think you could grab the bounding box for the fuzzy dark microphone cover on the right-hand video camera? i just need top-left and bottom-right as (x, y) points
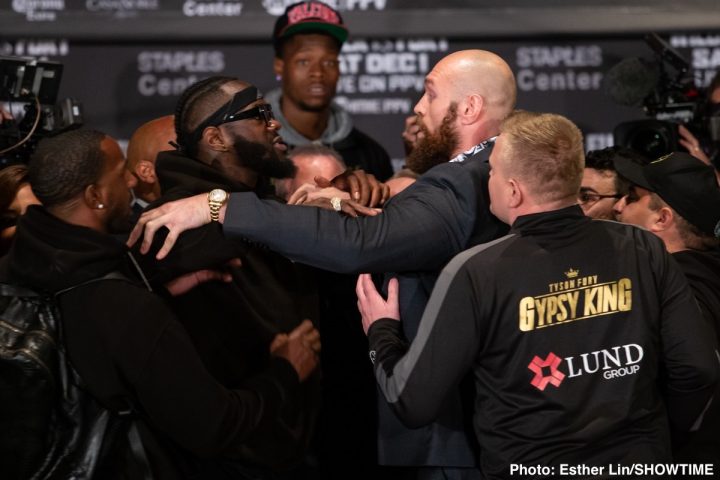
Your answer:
(602, 57), (660, 107)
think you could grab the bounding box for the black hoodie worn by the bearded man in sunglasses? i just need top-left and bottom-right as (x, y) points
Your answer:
(136, 152), (320, 470)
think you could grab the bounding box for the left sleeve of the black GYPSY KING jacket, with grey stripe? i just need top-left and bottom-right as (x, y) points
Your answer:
(368, 257), (482, 428)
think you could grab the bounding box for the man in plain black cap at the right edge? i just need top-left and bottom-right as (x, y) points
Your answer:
(614, 152), (720, 464)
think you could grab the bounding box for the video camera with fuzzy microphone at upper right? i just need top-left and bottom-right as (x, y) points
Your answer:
(603, 33), (720, 159)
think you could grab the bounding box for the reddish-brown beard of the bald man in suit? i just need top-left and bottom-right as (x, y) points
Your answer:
(405, 103), (460, 175)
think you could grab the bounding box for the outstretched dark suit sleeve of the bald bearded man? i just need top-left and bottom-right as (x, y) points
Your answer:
(223, 164), (479, 273)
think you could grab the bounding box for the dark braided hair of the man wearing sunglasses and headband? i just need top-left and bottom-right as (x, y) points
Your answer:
(175, 75), (240, 156)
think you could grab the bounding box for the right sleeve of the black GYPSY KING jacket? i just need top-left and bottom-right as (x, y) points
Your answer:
(656, 240), (720, 430)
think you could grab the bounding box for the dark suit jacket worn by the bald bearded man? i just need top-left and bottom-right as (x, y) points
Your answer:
(217, 150), (507, 467)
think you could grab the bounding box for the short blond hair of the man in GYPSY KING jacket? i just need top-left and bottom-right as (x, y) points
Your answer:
(500, 110), (585, 202)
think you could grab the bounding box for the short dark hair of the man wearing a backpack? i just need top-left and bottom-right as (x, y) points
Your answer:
(28, 130), (106, 207)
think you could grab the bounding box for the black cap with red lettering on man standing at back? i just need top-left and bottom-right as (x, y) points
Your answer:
(273, 1), (348, 50)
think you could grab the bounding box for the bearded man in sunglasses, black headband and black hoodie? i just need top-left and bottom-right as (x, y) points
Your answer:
(131, 76), (320, 478)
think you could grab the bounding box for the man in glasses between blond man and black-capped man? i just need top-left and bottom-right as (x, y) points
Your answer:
(578, 146), (647, 220)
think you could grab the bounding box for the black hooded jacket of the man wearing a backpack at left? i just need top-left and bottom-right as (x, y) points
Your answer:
(0, 206), (298, 479)
